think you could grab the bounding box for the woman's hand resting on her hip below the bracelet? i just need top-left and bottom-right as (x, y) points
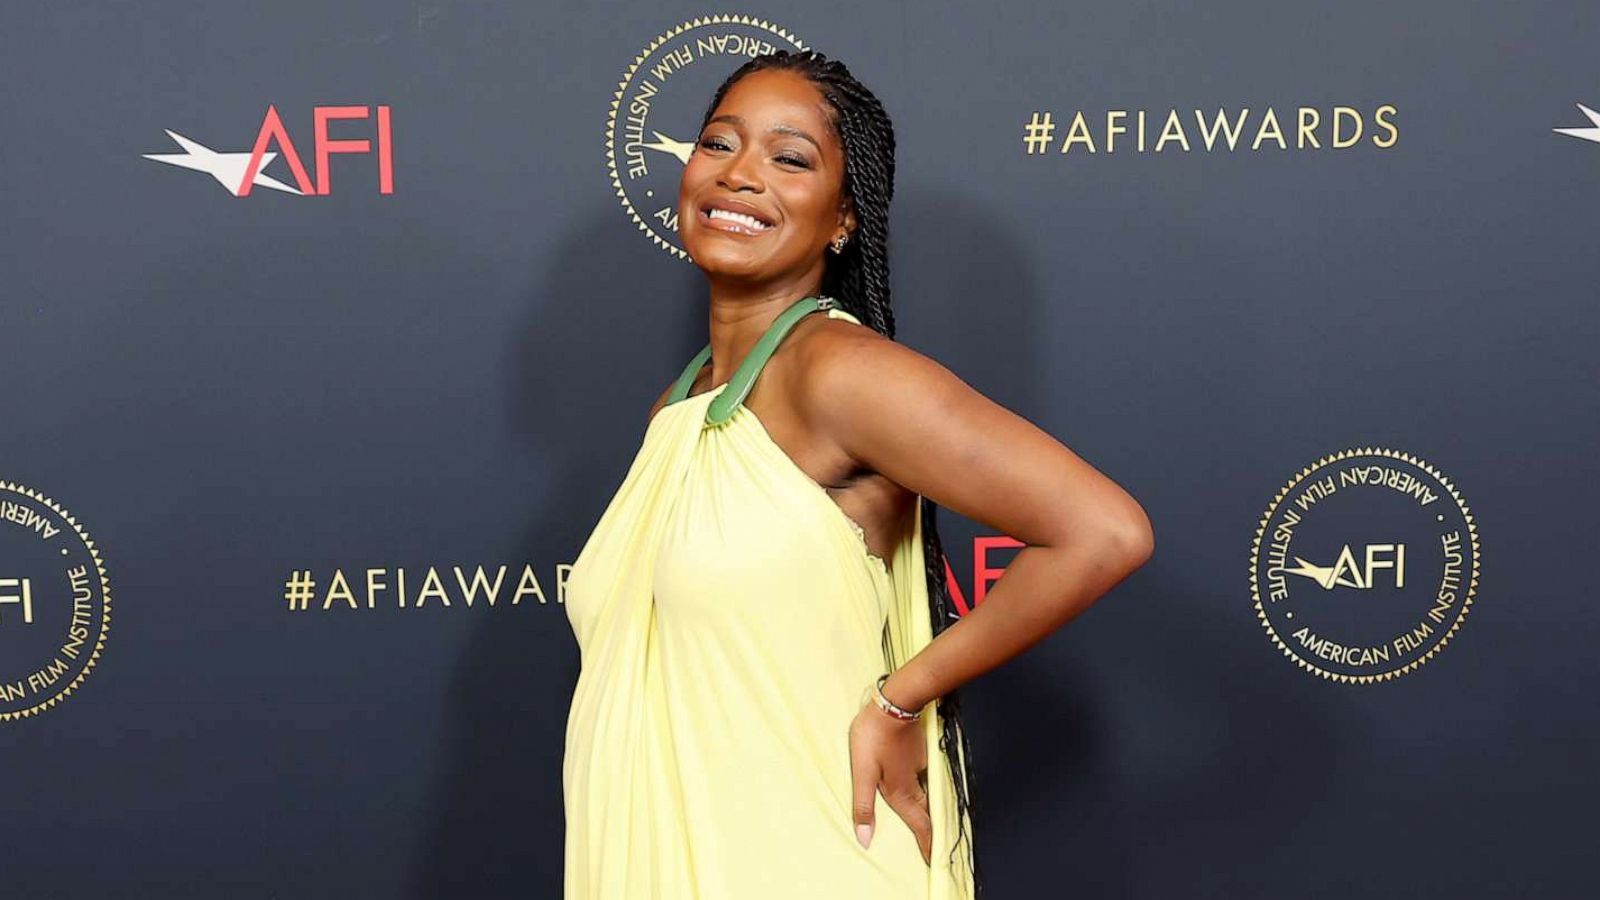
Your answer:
(850, 685), (933, 863)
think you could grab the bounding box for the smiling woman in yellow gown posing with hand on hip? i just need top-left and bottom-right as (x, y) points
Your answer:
(563, 51), (1154, 900)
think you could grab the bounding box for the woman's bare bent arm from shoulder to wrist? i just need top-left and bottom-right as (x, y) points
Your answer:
(798, 328), (1155, 709)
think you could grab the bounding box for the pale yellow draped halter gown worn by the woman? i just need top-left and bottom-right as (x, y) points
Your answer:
(562, 298), (973, 900)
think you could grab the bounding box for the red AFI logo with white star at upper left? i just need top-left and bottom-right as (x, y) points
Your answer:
(144, 106), (395, 197)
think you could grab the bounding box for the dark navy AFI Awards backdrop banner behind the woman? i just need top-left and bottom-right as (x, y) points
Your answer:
(0, 0), (1600, 900)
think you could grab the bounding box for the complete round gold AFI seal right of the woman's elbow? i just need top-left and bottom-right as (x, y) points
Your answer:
(1250, 447), (1478, 684)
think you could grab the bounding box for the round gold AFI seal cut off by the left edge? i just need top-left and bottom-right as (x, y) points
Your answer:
(0, 480), (110, 722)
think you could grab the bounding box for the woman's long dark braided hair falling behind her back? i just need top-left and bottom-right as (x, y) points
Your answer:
(701, 50), (981, 890)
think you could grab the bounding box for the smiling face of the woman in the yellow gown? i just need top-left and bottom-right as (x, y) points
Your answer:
(678, 69), (856, 282)
